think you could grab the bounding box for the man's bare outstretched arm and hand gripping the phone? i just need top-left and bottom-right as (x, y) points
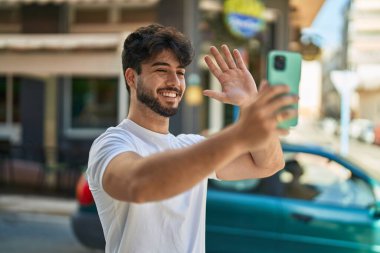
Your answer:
(102, 86), (295, 203)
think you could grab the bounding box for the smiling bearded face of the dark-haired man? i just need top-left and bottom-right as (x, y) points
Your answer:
(136, 50), (186, 117)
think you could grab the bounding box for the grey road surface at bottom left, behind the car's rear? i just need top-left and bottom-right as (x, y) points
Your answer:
(0, 212), (102, 253)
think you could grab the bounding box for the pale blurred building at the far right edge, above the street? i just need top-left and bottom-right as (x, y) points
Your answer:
(347, 0), (380, 124)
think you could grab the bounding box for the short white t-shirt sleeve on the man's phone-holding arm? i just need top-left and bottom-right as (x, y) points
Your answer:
(87, 129), (137, 189)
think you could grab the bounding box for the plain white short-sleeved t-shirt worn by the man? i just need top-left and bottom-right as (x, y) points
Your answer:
(87, 119), (215, 253)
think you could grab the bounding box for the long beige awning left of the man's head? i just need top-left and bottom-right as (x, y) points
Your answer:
(0, 34), (125, 76)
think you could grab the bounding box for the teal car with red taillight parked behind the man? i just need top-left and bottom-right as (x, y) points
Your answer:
(72, 144), (380, 253)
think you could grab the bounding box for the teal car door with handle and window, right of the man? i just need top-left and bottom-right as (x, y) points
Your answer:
(280, 153), (380, 253)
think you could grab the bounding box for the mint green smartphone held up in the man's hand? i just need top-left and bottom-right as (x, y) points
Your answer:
(267, 50), (302, 129)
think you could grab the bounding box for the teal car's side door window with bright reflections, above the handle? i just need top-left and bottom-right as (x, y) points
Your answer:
(280, 153), (375, 208)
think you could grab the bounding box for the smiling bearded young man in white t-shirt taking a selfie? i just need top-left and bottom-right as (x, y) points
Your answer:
(87, 25), (298, 253)
